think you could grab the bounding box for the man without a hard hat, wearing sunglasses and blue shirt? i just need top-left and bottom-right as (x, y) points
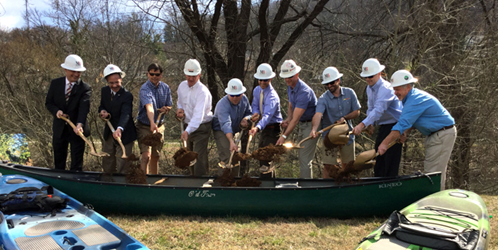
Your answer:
(136, 63), (173, 174)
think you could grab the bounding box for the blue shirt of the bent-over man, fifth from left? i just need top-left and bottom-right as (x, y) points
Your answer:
(213, 95), (252, 134)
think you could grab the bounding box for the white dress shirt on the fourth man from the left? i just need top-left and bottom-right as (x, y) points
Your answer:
(177, 81), (213, 134)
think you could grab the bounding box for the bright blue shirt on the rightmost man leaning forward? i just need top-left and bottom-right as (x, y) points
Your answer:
(392, 88), (455, 136)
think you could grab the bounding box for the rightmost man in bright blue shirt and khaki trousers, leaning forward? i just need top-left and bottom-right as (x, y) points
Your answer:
(378, 70), (457, 190)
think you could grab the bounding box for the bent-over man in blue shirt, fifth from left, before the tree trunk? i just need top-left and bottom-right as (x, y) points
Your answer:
(213, 78), (252, 176)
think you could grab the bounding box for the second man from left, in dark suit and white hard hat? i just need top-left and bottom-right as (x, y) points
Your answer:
(99, 64), (137, 174)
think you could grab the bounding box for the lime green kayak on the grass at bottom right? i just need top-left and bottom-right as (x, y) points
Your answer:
(356, 189), (490, 250)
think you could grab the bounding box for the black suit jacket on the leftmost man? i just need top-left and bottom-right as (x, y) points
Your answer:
(45, 77), (92, 138)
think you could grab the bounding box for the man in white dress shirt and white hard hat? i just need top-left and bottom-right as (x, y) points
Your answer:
(176, 59), (213, 176)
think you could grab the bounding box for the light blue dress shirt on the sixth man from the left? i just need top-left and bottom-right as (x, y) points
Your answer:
(252, 83), (283, 131)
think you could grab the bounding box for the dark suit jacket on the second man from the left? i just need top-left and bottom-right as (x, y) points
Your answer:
(99, 86), (137, 145)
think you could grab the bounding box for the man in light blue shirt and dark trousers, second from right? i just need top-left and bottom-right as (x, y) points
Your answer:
(353, 58), (403, 177)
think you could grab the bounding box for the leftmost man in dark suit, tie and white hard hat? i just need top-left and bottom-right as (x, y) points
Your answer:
(45, 55), (92, 171)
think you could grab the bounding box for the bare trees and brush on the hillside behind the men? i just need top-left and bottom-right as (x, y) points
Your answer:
(0, 0), (498, 193)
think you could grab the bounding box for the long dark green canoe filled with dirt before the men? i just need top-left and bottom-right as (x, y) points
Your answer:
(0, 163), (441, 218)
